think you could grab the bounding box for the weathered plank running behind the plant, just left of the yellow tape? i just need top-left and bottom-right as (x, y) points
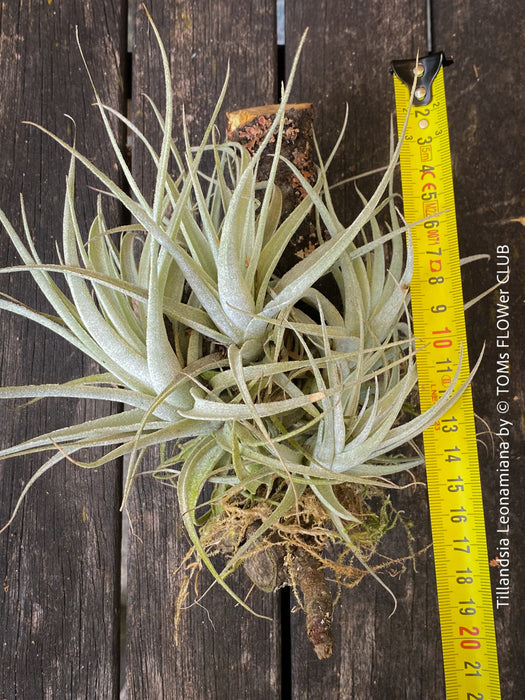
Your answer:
(286, 0), (450, 700)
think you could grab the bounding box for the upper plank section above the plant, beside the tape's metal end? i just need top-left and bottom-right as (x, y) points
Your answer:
(285, 0), (426, 223)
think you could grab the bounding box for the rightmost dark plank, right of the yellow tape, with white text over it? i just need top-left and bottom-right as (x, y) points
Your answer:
(434, 0), (525, 698)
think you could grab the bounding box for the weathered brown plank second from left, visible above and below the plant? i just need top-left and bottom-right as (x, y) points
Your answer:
(127, 0), (280, 700)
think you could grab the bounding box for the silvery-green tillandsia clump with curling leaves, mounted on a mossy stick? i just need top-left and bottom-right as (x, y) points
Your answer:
(0, 19), (476, 657)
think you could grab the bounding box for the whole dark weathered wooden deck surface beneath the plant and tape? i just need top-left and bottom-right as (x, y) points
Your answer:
(0, 0), (525, 700)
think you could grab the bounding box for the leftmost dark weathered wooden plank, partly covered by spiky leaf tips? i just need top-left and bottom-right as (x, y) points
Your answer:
(0, 0), (123, 699)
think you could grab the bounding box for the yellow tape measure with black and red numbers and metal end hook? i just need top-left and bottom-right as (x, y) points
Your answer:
(392, 53), (501, 700)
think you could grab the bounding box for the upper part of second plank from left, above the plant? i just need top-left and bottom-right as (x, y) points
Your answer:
(133, 0), (277, 201)
